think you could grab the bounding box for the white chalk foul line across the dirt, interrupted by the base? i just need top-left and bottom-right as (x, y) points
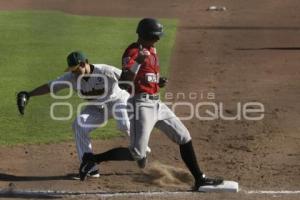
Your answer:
(0, 189), (300, 197)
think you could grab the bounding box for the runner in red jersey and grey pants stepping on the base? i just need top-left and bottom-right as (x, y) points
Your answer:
(80, 18), (223, 190)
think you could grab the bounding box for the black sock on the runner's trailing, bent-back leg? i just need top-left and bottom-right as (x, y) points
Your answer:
(93, 147), (134, 163)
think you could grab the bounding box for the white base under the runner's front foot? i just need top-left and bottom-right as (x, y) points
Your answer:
(198, 181), (239, 192)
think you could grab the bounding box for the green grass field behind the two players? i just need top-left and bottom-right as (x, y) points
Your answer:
(0, 11), (177, 145)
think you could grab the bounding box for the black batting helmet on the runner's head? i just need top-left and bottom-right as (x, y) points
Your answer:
(136, 18), (163, 40)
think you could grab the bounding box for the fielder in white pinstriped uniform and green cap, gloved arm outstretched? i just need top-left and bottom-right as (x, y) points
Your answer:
(17, 51), (130, 177)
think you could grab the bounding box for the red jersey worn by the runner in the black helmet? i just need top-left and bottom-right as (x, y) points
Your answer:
(122, 43), (160, 94)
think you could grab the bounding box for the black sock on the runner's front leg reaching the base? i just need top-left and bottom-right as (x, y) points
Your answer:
(180, 141), (203, 181)
